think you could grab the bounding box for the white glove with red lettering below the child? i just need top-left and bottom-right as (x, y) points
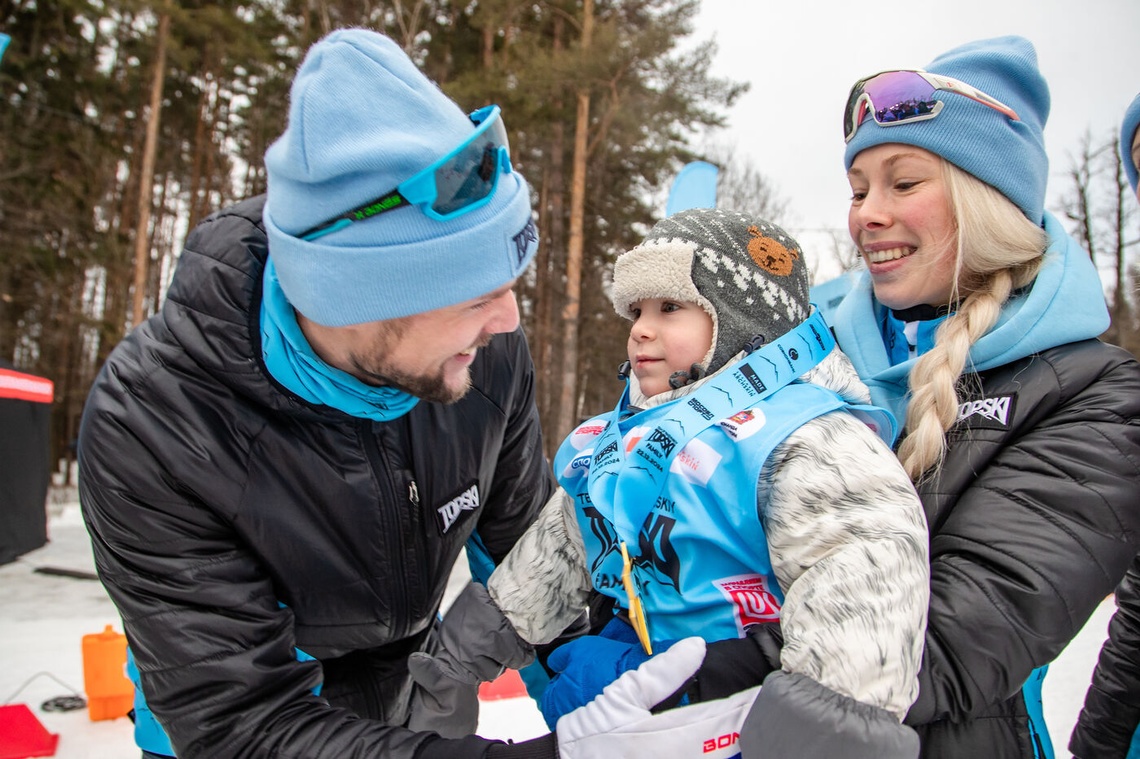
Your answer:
(556, 638), (760, 759)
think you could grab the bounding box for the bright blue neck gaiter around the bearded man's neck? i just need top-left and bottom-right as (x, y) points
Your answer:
(261, 258), (420, 422)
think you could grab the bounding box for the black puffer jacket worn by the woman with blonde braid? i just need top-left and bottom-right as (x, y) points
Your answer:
(906, 340), (1140, 759)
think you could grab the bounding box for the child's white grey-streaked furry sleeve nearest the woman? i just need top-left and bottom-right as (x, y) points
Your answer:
(759, 411), (930, 720)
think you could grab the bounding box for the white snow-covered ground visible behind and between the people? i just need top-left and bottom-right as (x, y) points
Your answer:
(0, 499), (1115, 759)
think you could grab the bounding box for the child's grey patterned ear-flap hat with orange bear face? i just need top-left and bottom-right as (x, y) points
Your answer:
(613, 209), (811, 373)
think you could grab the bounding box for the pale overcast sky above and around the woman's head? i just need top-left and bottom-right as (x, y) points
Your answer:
(694, 0), (1140, 254)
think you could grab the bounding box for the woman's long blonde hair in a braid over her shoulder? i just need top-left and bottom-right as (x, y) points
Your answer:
(898, 161), (1048, 482)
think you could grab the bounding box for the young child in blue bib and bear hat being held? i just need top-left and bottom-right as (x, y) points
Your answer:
(421, 210), (929, 757)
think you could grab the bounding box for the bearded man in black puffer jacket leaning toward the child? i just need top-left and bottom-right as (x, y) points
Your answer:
(80, 30), (725, 759)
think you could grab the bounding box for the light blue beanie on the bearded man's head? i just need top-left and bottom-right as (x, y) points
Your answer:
(263, 28), (538, 327)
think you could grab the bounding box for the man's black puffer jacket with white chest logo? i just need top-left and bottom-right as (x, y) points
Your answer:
(80, 198), (552, 759)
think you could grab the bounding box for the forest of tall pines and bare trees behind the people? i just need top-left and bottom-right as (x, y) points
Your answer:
(0, 0), (1140, 476)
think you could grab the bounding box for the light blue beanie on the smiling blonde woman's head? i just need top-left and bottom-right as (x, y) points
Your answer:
(844, 36), (1050, 225)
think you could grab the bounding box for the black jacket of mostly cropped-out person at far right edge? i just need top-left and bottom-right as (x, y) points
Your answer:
(1069, 555), (1140, 759)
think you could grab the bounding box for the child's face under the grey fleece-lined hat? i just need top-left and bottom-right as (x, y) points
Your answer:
(626, 297), (713, 397)
